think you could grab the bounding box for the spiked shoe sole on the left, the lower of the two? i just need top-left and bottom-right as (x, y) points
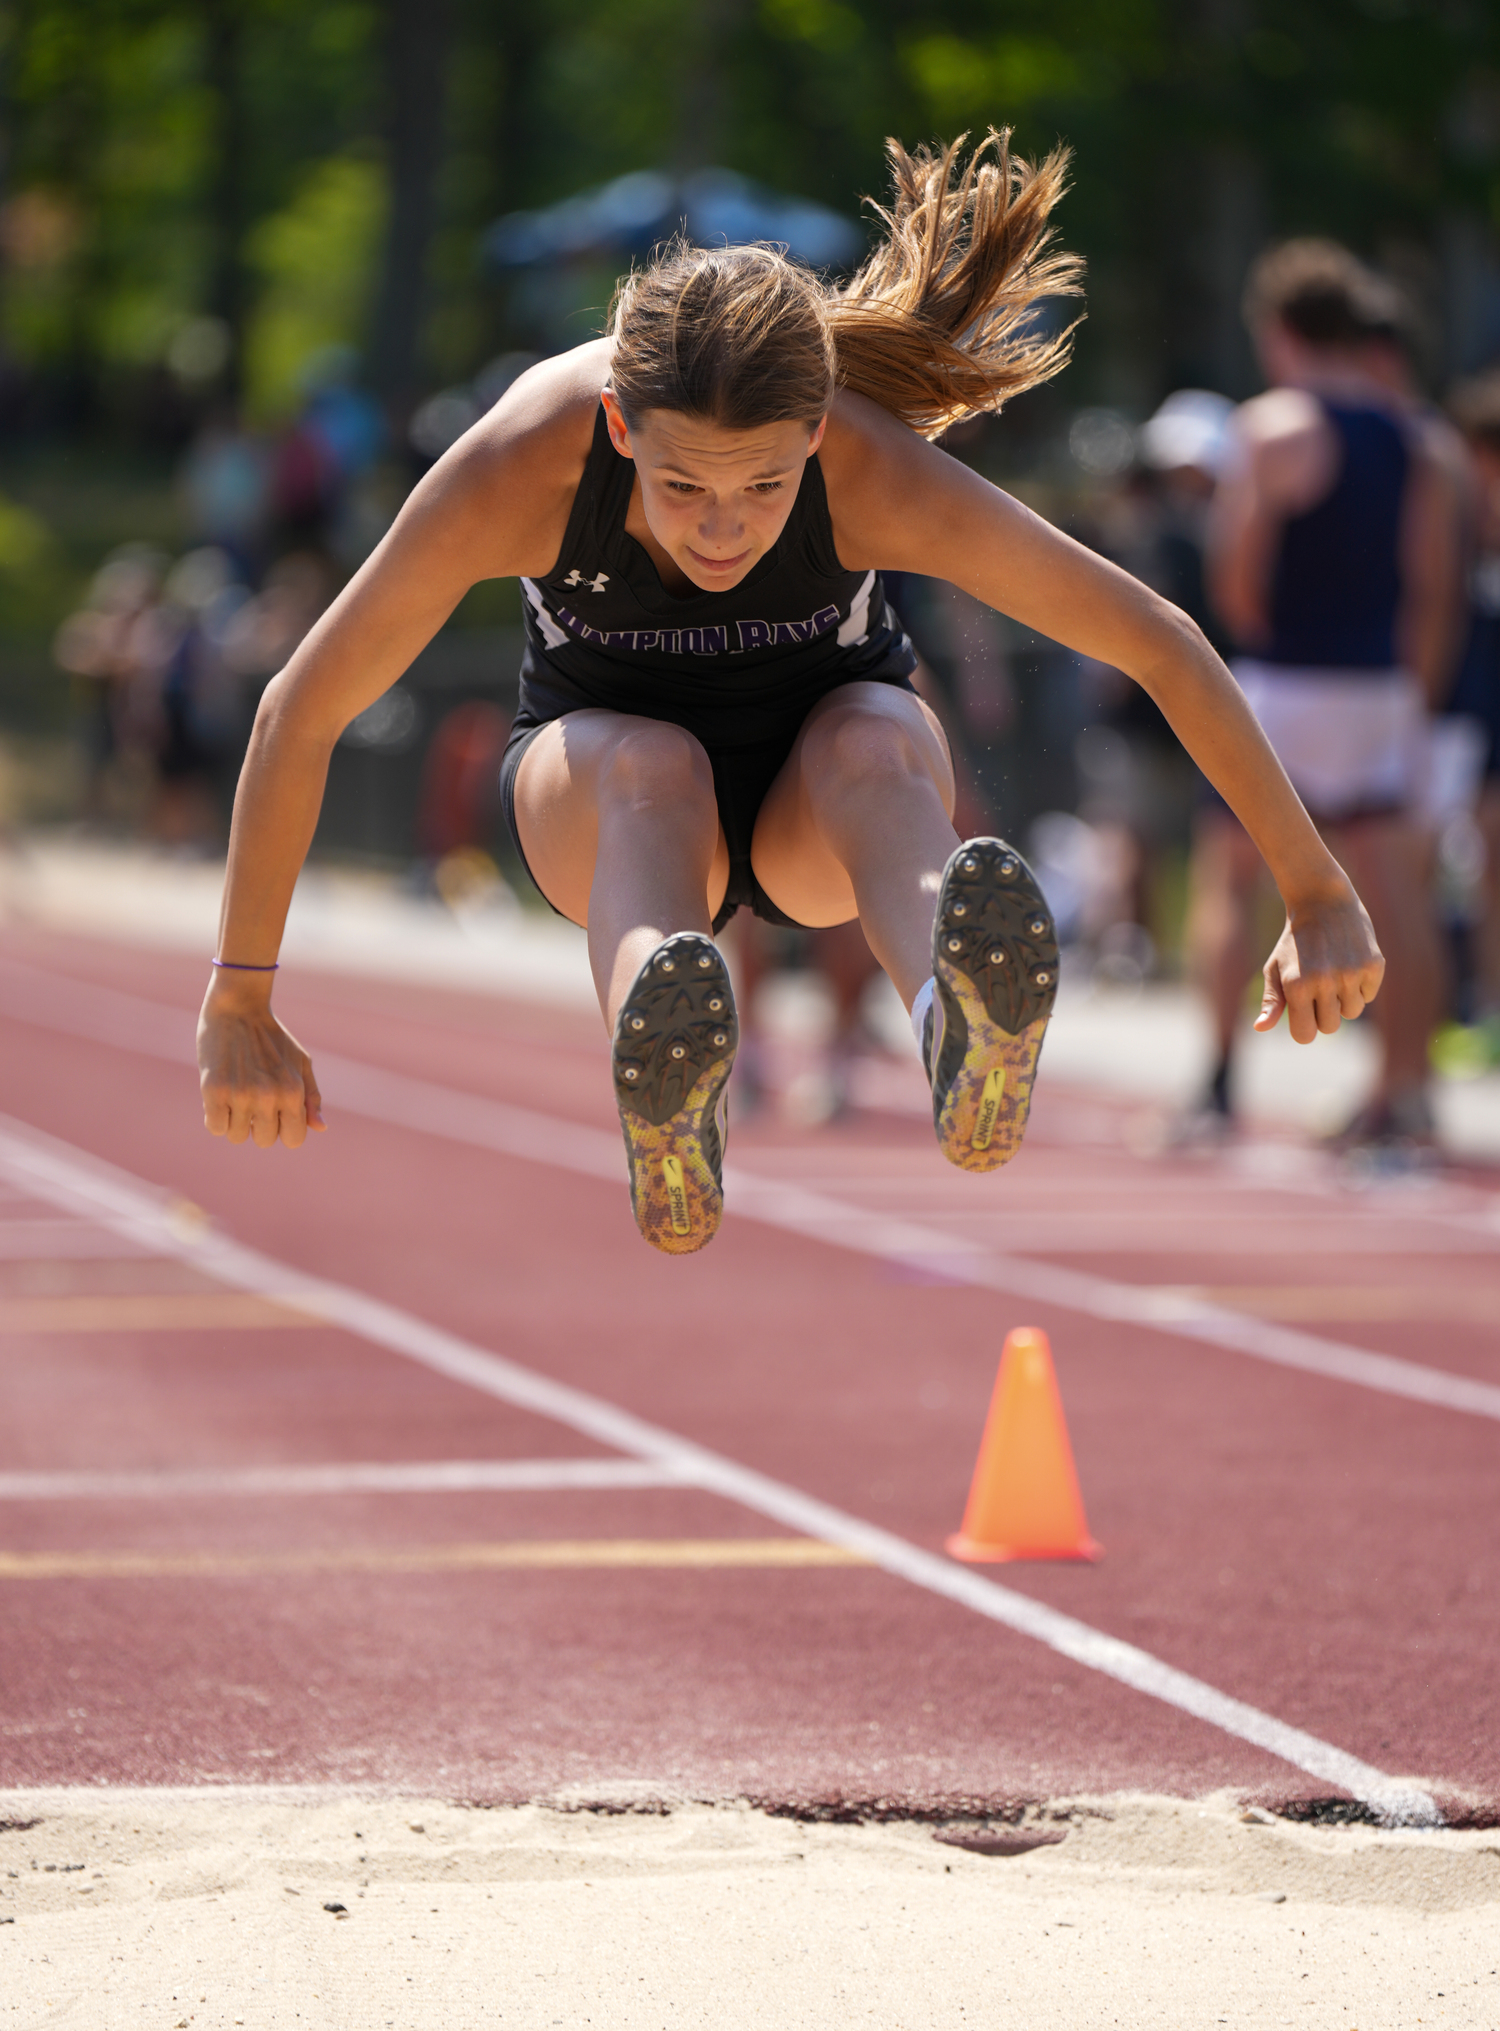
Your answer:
(613, 930), (739, 1255)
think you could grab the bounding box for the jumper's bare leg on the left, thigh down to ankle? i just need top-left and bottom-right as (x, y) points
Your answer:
(516, 709), (729, 1028)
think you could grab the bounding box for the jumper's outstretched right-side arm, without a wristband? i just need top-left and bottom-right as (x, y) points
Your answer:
(822, 394), (1384, 1044)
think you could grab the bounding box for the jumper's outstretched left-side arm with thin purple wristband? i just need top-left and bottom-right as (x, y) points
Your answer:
(199, 345), (605, 1148)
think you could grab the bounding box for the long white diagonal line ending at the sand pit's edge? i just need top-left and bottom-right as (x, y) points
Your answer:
(0, 1117), (1441, 1826)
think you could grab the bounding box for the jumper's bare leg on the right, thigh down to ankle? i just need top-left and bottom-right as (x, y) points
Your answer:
(751, 682), (958, 1007)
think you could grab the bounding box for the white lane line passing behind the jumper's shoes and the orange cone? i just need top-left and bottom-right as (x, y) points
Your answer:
(0, 961), (1500, 1420)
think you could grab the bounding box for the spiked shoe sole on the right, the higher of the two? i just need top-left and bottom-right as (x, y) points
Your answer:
(922, 839), (1058, 1170)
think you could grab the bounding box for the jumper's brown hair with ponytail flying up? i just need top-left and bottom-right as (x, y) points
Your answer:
(609, 128), (1082, 437)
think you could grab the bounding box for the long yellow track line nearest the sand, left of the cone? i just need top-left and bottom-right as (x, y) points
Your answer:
(0, 1537), (871, 1580)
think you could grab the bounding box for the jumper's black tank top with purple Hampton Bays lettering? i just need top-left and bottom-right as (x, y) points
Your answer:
(518, 402), (915, 749)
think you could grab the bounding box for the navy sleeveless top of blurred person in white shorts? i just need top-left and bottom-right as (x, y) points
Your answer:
(1263, 402), (1411, 670)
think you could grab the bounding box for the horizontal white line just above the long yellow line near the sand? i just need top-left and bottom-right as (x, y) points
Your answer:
(0, 1460), (684, 1503)
